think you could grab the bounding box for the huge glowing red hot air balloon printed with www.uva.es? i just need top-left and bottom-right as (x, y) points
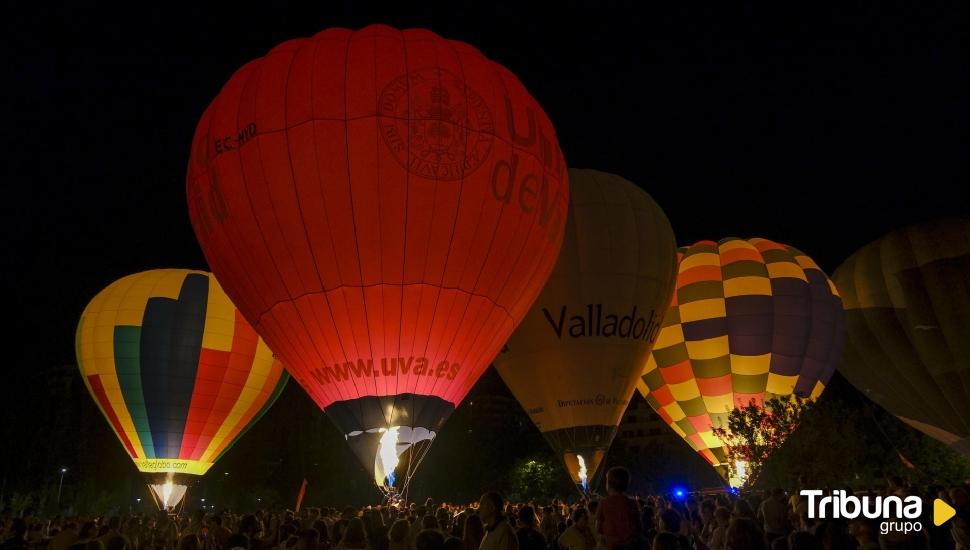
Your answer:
(186, 26), (568, 496)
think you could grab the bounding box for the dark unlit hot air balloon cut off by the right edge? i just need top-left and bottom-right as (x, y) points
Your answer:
(833, 219), (970, 456)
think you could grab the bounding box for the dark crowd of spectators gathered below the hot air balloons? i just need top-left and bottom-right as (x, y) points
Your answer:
(0, 468), (970, 550)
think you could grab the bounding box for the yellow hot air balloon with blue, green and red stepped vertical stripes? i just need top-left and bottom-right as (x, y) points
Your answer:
(76, 269), (289, 510)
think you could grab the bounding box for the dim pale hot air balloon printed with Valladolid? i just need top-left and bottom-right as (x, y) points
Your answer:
(495, 169), (677, 491)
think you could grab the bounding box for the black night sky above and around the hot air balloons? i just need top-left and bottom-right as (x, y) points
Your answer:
(0, 1), (970, 504)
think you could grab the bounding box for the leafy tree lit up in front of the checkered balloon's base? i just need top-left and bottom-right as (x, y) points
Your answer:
(713, 396), (811, 487)
